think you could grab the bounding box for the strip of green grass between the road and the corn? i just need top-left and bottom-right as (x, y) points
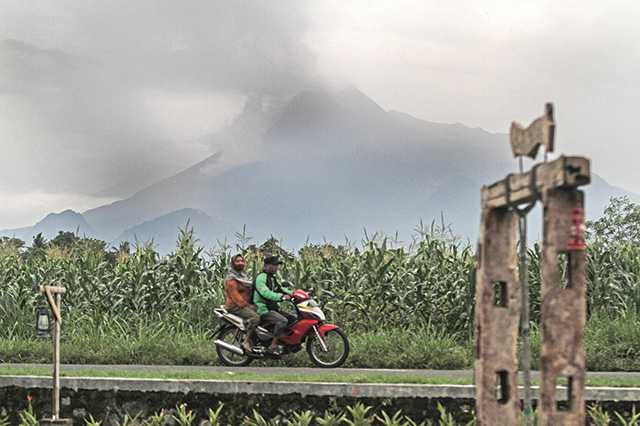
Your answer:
(6, 314), (640, 371)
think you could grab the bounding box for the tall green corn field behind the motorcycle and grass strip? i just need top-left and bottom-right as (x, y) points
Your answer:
(0, 197), (640, 339)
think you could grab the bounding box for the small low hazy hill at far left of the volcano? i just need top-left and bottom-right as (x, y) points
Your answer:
(0, 210), (95, 243)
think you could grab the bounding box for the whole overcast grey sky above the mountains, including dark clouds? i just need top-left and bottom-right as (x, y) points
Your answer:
(0, 0), (640, 228)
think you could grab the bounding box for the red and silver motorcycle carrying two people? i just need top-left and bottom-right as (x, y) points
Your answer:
(214, 290), (349, 368)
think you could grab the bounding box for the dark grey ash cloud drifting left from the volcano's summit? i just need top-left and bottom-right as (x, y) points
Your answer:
(0, 0), (314, 201)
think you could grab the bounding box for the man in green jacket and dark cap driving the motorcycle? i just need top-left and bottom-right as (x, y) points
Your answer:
(253, 256), (296, 354)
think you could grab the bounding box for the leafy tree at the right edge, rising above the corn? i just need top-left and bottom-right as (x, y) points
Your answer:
(587, 196), (640, 243)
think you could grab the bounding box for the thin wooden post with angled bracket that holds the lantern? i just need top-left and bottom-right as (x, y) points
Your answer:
(39, 285), (73, 426)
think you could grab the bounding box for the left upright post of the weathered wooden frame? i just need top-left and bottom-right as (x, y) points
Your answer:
(474, 208), (521, 425)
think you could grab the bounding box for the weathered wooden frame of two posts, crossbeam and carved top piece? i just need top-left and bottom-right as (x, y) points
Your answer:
(474, 104), (591, 425)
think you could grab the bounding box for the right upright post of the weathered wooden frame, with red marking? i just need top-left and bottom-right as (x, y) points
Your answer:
(539, 189), (586, 426)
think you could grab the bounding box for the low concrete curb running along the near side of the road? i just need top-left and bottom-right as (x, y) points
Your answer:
(0, 376), (640, 402)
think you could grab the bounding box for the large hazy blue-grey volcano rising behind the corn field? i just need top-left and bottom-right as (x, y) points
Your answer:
(7, 88), (635, 248)
